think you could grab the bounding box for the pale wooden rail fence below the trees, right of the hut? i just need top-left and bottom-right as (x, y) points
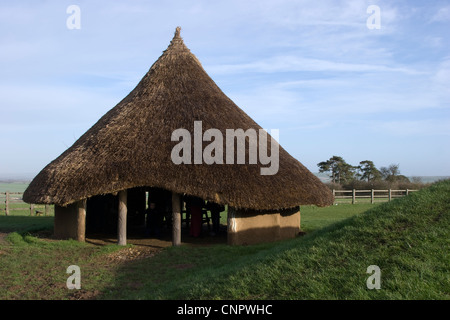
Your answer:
(333, 189), (417, 204)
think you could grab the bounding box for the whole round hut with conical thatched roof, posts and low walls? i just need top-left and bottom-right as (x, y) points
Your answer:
(23, 28), (333, 244)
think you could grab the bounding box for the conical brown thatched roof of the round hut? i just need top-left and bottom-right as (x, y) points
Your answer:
(23, 28), (333, 210)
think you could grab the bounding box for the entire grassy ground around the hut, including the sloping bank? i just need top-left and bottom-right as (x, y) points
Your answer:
(0, 181), (450, 300)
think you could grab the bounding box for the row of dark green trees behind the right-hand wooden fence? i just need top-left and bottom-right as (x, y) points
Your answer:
(317, 156), (426, 189)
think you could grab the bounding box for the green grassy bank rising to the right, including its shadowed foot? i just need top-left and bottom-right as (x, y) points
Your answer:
(103, 181), (450, 299)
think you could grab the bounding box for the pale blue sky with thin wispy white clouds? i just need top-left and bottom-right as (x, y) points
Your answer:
(0, 0), (450, 178)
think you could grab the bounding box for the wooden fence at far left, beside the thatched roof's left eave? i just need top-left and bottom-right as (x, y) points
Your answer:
(0, 191), (52, 216)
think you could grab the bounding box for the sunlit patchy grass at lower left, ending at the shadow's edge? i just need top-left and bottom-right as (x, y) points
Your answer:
(0, 232), (123, 300)
